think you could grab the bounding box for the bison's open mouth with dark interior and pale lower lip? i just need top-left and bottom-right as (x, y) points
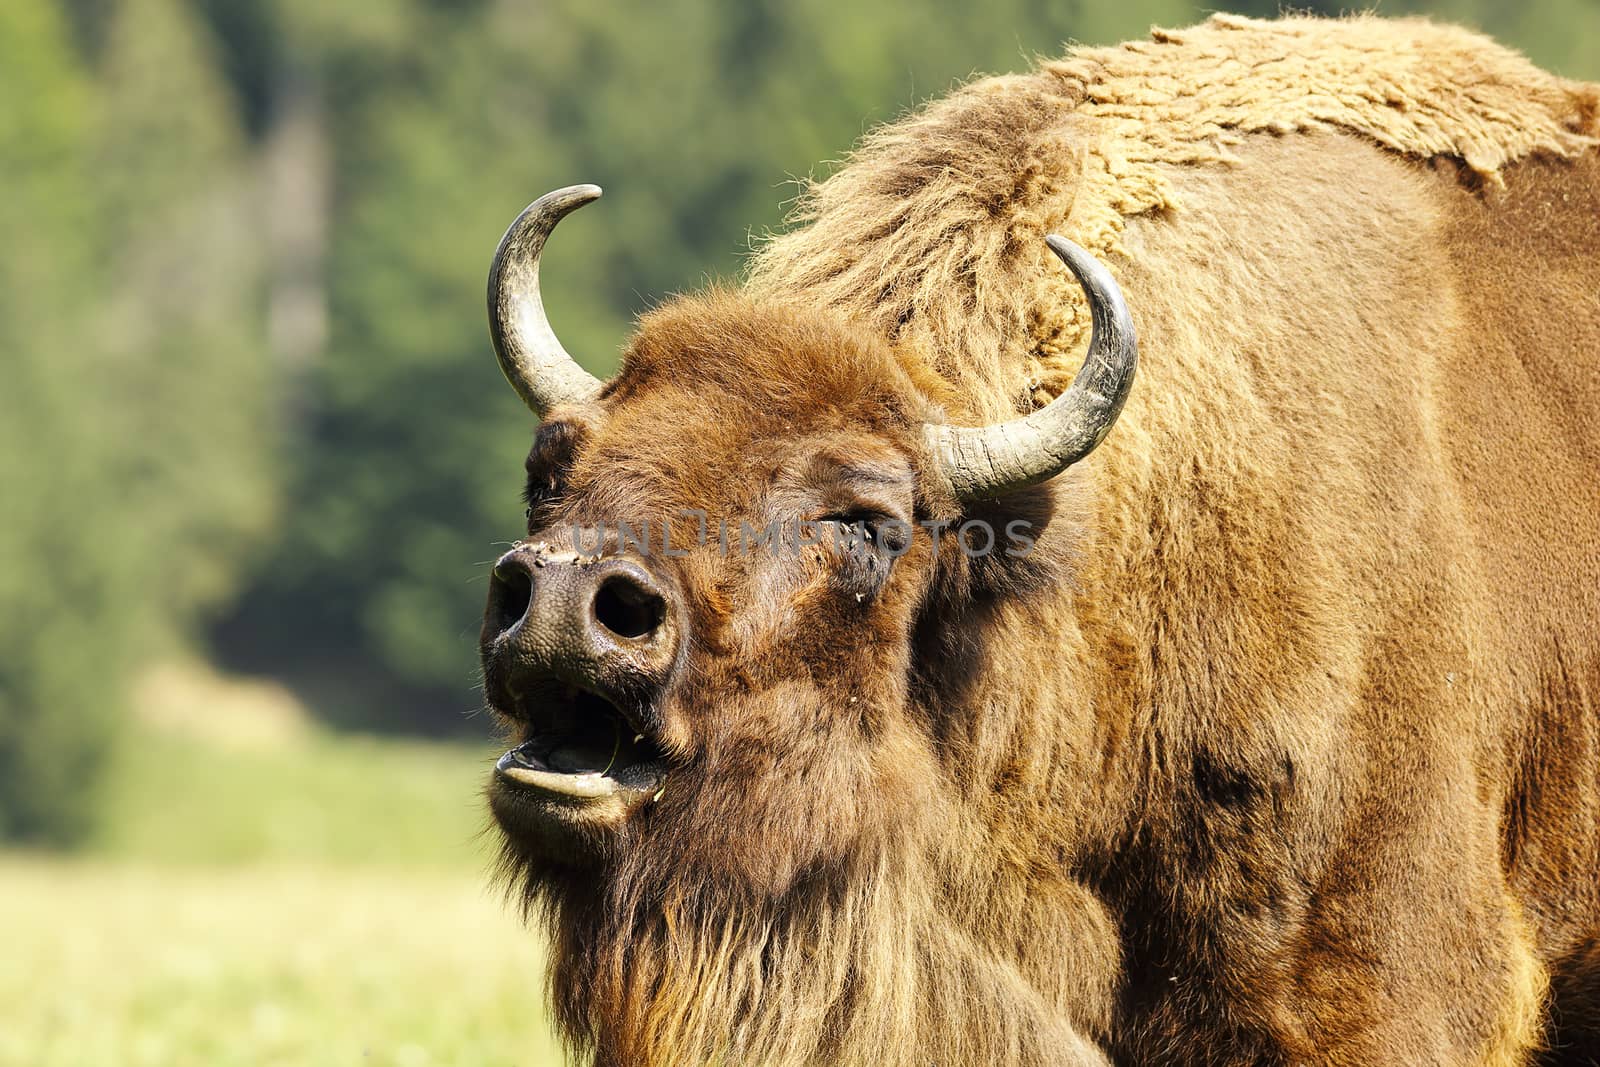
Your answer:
(494, 685), (667, 800)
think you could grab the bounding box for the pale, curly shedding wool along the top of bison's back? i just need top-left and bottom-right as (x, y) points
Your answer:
(1043, 14), (1600, 251)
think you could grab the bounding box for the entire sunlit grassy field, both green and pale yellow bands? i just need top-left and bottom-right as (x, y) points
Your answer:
(0, 668), (562, 1067)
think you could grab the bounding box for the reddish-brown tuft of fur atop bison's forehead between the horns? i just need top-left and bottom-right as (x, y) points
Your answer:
(606, 290), (955, 432)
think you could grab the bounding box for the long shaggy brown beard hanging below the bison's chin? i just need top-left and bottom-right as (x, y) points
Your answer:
(510, 835), (1107, 1067)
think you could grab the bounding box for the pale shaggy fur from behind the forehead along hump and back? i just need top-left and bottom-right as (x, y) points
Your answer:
(749, 14), (1600, 418)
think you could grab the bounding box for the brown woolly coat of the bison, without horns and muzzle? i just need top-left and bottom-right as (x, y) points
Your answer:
(492, 18), (1600, 1067)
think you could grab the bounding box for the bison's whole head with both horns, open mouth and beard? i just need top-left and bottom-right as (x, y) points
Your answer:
(482, 187), (1136, 1062)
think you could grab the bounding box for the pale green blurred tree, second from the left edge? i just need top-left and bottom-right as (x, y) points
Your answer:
(93, 0), (277, 625)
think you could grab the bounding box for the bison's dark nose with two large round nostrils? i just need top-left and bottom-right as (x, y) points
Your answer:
(483, 545), (674, 688)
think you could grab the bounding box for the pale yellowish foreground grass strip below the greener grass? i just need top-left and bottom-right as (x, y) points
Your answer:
(0, 857), (562, 1067)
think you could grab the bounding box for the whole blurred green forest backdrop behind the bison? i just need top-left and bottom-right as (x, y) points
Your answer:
(0, 0), (1600, 841)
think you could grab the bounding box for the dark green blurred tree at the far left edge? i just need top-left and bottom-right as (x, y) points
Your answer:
(0, 0), (116, 840)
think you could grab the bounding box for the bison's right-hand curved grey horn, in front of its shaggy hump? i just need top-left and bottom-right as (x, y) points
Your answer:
(928, 234), (1139, 501)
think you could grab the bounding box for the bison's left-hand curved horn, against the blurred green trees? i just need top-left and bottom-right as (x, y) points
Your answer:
(490, 186), (602, 416)
